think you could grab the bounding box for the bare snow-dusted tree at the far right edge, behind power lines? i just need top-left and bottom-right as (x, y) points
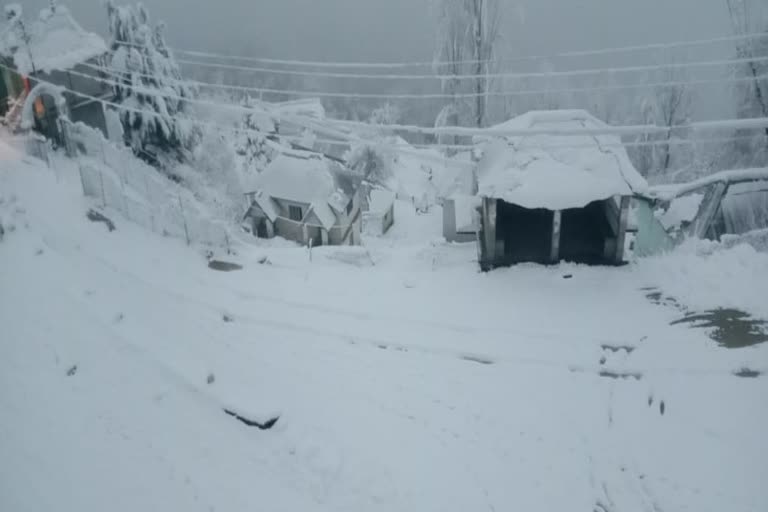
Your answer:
(725, 0), (768, 166)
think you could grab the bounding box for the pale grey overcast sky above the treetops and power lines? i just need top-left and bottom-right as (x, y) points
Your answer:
(25, 0), (752, 117)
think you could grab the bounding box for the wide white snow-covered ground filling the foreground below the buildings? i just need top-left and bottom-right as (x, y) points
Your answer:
(0, 142), (768, 512)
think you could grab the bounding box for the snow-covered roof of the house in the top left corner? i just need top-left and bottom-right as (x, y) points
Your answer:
(0, 5), (107, 75)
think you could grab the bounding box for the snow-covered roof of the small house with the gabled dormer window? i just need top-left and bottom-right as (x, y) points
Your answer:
(247, 151), (354, 229)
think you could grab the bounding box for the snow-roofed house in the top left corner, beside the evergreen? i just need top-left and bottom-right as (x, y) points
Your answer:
(0, 3), (112, 140)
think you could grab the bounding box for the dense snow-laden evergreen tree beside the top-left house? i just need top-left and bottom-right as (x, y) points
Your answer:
(107, 0), (196, 159)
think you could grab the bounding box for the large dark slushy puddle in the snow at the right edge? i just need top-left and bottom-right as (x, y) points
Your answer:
(671, 309), (768, 348)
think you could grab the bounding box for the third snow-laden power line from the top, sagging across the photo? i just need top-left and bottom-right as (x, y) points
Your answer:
(83, 59), (768, 100)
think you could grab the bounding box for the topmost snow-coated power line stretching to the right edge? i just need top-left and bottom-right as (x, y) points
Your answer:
(166, 32), (766, 69)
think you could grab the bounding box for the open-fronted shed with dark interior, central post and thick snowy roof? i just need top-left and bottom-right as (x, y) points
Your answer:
(477, 110), (647, 270)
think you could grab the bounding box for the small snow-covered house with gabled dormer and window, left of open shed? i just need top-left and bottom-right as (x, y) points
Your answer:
(245, 151), (362, 246)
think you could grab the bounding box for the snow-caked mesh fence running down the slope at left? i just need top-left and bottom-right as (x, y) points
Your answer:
(62, 120), (231, 248)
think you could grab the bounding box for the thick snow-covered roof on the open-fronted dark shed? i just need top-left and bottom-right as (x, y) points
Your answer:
(476, 110), (648, 210)
